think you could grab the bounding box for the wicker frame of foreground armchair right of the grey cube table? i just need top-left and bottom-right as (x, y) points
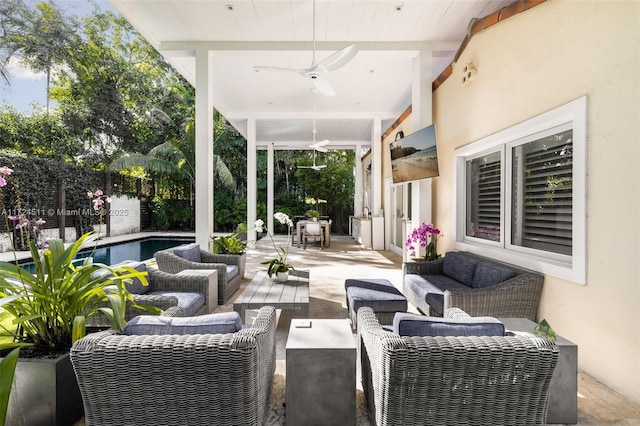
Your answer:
(358, 307), (558, 426)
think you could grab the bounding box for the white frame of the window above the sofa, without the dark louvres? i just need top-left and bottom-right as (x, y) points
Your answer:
(454, 96), (587, 284)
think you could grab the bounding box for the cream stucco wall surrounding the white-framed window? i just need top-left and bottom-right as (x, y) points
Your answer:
(433, 0), (640, 402)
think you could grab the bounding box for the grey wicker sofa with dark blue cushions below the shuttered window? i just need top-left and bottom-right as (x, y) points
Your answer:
(403, 252), (544, 321)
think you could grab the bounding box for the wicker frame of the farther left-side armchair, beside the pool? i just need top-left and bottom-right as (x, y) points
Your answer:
(154, 249), (247, 305)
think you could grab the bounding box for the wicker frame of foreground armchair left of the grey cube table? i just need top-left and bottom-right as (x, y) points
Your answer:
(71, 307), (276, 426)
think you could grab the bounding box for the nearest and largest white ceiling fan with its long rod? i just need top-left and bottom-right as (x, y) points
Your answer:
(254, 0), (358, 96)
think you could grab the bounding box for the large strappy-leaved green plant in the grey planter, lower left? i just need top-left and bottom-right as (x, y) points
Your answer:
(0, 233), (147, 353)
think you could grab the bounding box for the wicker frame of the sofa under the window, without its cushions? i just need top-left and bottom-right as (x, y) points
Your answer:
(403, 252), (544, 321)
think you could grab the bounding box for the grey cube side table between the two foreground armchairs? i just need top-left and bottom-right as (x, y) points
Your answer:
(286, 319), (356, 426)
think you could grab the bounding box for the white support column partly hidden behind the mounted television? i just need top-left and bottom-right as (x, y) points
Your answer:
(411, 50), (433, 227)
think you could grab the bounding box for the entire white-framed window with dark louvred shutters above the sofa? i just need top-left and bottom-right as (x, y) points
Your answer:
(455, 98), (586, 283)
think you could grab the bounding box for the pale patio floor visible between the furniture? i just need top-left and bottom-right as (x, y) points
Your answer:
(217, 235), (640, 425)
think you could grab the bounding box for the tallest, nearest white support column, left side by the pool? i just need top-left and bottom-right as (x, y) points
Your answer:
(195, 49), (213, 249)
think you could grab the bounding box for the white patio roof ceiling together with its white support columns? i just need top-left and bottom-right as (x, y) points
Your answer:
(111, 0), (502, 244)
